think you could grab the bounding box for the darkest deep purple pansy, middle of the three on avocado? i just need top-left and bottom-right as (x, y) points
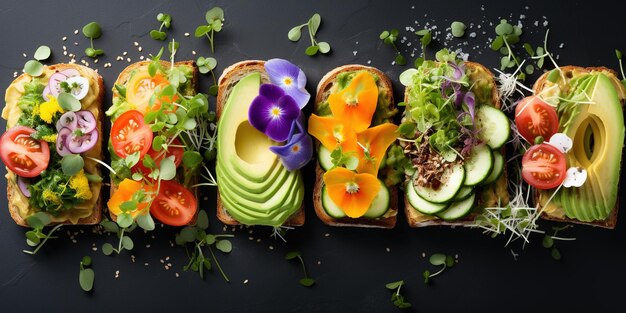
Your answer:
(248, 84), (300, 142)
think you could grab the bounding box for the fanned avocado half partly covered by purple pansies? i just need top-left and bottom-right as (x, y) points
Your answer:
(216, 72), (304, 226)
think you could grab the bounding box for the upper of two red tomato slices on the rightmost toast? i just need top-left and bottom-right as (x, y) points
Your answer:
(515, 96), (559, 144)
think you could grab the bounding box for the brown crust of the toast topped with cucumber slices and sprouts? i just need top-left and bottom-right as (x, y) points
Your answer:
(404, 61), (509, 228)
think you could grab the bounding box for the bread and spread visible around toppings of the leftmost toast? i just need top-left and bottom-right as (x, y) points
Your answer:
(2, 64), (104, 226)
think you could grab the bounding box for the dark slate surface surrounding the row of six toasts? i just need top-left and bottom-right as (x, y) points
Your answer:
(0, 0), (626, 312)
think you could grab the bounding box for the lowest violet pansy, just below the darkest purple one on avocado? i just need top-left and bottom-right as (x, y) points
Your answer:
(270, 118), (313, 171)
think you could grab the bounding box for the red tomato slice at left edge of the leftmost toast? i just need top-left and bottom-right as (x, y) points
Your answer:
(0, 126), (50, 177)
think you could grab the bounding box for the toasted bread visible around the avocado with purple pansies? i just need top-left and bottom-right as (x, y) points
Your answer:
(215, 60), (305, 226)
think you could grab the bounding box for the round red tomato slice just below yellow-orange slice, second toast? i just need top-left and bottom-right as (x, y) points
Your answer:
(111, 110), (152, 158)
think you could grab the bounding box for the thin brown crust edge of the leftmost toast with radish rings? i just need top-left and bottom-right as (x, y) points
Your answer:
(7, 63), (105, 227)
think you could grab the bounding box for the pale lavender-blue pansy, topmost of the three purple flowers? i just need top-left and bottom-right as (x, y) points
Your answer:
(265, 59), (311, 109)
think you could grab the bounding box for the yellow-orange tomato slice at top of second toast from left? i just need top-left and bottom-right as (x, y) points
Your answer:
(126, 70), (178, 114)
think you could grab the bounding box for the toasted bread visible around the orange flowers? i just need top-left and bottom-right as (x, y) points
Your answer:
(313, 64), (398, 228)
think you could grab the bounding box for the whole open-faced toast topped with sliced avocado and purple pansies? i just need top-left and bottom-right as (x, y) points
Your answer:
(215, 59), (312, 227)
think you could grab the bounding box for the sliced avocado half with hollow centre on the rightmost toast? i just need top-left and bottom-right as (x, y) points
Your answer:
(540, 72), (625, 222)
